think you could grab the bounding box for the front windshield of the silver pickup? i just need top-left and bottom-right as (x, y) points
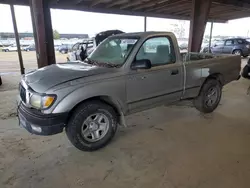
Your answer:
(88, 37), (138, 66)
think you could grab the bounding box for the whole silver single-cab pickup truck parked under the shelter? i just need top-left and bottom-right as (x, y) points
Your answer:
(18, 32), (241, 151)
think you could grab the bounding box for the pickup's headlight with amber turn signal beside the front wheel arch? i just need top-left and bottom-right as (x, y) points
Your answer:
(30, 94), (56, 109)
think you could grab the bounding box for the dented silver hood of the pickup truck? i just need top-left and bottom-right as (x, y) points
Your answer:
(24, 62), (114, 93)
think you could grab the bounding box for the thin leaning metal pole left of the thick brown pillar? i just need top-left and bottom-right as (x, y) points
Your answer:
(10, 5), (25, 74)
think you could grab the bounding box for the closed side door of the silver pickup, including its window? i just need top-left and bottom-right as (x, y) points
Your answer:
(126, 37), (183, 112)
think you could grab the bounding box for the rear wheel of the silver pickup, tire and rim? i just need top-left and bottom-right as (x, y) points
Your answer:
(194, 79), (222, 113)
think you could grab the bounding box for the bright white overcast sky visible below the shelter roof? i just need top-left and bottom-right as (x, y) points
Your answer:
(0, 4), (250, 37)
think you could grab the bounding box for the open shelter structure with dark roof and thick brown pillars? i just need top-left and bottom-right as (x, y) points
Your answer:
(0, 0), (250, 70)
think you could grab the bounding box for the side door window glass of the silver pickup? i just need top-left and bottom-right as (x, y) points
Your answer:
(136, 37), (176, 66)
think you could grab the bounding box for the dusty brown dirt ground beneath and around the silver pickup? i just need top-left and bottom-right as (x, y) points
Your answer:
(0, 53), (250, 188)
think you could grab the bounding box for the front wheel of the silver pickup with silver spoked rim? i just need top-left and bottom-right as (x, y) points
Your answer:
(66, 101), (118, 151)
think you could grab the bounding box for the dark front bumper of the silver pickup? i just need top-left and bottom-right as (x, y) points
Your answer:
(18, 103), (68, 135)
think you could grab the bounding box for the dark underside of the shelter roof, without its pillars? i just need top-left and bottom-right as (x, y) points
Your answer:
(0, 0), (250, 22)
